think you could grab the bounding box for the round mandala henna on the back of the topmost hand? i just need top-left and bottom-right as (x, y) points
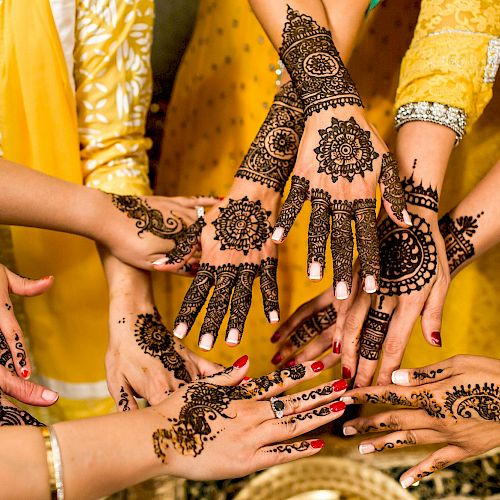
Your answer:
(314, 116), (379, 182)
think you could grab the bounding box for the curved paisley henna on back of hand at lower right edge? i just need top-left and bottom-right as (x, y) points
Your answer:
(444, 382), (500, 422)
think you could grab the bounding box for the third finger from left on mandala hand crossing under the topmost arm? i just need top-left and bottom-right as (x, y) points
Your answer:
(226, 263), (259, 346)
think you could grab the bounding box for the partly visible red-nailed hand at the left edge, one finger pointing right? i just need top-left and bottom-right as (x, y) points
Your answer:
(0, 264), (54, 379)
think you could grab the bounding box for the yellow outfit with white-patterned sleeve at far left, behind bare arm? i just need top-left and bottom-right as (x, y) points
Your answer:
(0, 0), (154, 420)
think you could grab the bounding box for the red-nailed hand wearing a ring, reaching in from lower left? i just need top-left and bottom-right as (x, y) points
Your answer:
(148, 356), (346, 481)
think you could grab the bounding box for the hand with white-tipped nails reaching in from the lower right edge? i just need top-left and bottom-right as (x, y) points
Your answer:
(344, 356), (500, 487)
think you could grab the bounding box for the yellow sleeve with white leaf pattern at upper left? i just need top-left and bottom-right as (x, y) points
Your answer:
(75, 0), (154, 195)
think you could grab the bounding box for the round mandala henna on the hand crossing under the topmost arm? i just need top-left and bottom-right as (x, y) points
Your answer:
(212, 196), (271, 255)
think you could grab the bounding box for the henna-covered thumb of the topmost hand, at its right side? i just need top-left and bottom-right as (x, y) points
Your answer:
(379, 152), (412, 227)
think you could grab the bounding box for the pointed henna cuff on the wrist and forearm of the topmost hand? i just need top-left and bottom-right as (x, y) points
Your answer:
(279, 6), (362, 117)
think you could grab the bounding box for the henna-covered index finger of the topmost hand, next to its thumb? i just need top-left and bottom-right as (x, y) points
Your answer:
(354, 199), (380, 293)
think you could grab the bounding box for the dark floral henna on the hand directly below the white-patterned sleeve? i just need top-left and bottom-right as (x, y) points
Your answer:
(134, 307), (191, 382)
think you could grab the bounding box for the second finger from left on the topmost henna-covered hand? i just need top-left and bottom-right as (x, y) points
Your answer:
(307, 189), (331, 280)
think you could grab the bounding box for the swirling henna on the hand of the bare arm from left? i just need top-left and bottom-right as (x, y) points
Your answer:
(111, 194), (186, 239)
